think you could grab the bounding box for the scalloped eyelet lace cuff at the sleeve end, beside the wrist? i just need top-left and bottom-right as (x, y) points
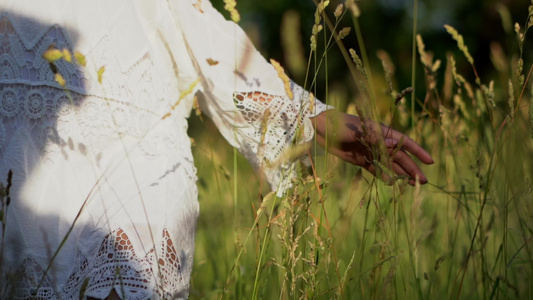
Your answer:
(233, 82), (330, 194)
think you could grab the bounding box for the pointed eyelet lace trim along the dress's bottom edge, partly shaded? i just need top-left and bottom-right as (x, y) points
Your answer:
(2, 229), (190, 299)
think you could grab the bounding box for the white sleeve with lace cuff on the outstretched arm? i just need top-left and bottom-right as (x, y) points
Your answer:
(171, 0), (328, 193)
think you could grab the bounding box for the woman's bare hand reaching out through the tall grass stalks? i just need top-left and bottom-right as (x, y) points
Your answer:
(311, 110), (433, 185)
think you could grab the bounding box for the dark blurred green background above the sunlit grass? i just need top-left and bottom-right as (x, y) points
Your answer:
(212, 0), (533, 101)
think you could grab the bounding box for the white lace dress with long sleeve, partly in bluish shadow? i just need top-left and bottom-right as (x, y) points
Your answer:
(0, 0), (326, 299)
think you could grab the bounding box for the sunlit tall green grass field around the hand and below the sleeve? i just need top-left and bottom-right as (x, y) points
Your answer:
(190, 0), (533, 299)
